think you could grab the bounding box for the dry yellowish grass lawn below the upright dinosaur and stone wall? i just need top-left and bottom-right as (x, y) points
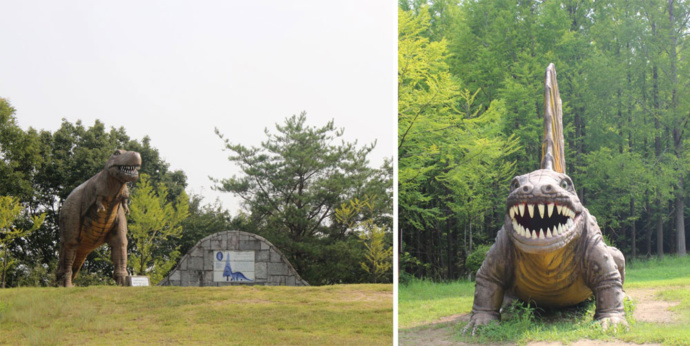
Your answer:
(0, 284), (393, 345)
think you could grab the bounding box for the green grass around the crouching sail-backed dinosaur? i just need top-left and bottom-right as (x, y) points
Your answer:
(398, 256), (690, 345)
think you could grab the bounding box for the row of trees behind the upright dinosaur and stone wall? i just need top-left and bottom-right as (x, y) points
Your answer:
(0, 102), (393, 287)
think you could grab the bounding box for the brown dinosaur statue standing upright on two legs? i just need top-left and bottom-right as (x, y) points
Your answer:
(56, 149), (141, 287)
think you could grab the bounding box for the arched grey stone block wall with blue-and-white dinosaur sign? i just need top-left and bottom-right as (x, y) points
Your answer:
(158, 231), (309, 286)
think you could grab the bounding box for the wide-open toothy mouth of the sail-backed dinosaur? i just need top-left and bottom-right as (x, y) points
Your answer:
(508, 203), (579, 240)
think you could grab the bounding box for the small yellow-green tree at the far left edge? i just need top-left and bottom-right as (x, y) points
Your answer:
(0, 196), (45, 288)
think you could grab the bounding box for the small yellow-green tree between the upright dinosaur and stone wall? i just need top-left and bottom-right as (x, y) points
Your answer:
(128, 173), (189, 284)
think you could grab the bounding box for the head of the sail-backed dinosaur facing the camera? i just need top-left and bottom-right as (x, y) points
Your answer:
(505, 169), (585, 253)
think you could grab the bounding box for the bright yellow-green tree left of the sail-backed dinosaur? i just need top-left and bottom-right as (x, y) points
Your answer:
(398, 8), (517, 278)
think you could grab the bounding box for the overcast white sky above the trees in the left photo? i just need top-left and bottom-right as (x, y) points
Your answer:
(0, 0), (397, 215)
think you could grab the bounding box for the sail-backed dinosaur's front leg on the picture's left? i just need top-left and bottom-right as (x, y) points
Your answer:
(463, 230), (512, 335)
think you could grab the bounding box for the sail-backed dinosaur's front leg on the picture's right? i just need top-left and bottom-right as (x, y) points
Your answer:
(585, 241), (628, 329)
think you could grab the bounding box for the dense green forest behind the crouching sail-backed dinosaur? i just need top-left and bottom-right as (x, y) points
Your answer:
(397, 0), (690, 282)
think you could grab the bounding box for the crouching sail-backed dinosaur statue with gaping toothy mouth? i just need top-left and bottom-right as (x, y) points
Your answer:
(463, 64), (627, 335)
